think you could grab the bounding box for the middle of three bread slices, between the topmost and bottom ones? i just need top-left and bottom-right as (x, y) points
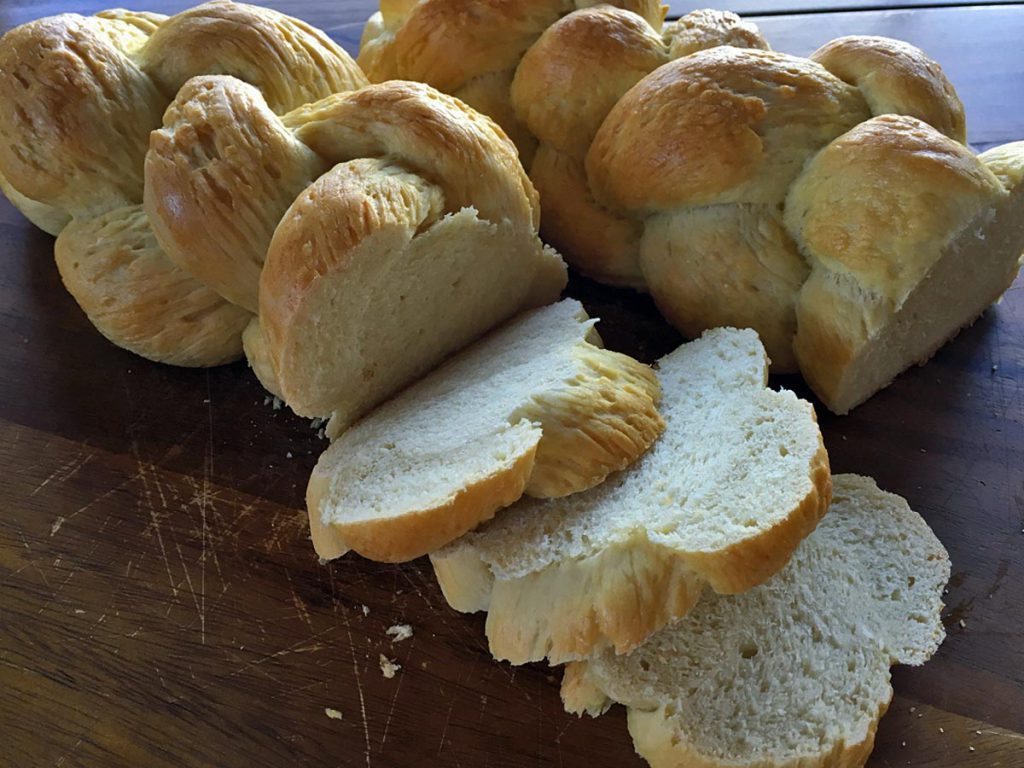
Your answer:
(431, 329), (831, 664)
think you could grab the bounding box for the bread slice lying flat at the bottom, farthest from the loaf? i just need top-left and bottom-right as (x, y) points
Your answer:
(562, 475), (949, 768)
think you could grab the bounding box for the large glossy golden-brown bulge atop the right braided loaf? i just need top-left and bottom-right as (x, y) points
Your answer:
(587, 46), (868, 212)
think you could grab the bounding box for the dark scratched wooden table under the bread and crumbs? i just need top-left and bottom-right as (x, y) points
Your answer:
(0, 0), (1024, 768)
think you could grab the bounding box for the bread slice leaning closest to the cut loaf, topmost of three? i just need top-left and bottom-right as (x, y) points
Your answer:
(306, 300), (664, 561)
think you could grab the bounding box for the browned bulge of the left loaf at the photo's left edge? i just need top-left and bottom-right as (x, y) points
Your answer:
(0, 13), (165, 215)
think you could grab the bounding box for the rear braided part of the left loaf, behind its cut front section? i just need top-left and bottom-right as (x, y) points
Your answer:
(0, 0), (366, 366)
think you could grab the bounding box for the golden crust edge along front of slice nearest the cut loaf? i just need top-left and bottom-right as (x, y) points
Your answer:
(306, 445), (536, 562)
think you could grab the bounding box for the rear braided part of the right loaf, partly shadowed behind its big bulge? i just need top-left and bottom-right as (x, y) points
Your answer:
(358, 5), (768, 288)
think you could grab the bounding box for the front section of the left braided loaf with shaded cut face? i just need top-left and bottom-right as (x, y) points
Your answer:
(145, 76), (566, 437)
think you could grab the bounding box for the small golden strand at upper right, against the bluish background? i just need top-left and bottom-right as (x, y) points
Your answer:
(811, 35), (967, 143)
